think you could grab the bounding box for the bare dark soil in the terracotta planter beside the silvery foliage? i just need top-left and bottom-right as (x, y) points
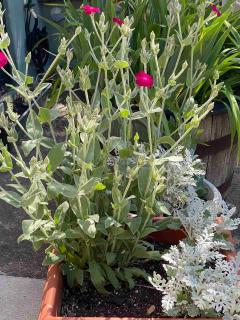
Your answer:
(61, 261), (165, 318)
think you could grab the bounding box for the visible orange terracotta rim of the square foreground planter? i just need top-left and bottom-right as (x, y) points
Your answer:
(38, 233), (236, 320)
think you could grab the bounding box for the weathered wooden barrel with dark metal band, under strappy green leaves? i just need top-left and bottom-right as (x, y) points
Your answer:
(196, 110), (237, 194)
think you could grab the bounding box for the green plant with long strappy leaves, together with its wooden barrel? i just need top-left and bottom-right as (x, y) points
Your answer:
(42, 0), (240, 193)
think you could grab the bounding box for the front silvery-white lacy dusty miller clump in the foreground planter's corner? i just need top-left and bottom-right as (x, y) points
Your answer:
(150, 232), (240, 319)
